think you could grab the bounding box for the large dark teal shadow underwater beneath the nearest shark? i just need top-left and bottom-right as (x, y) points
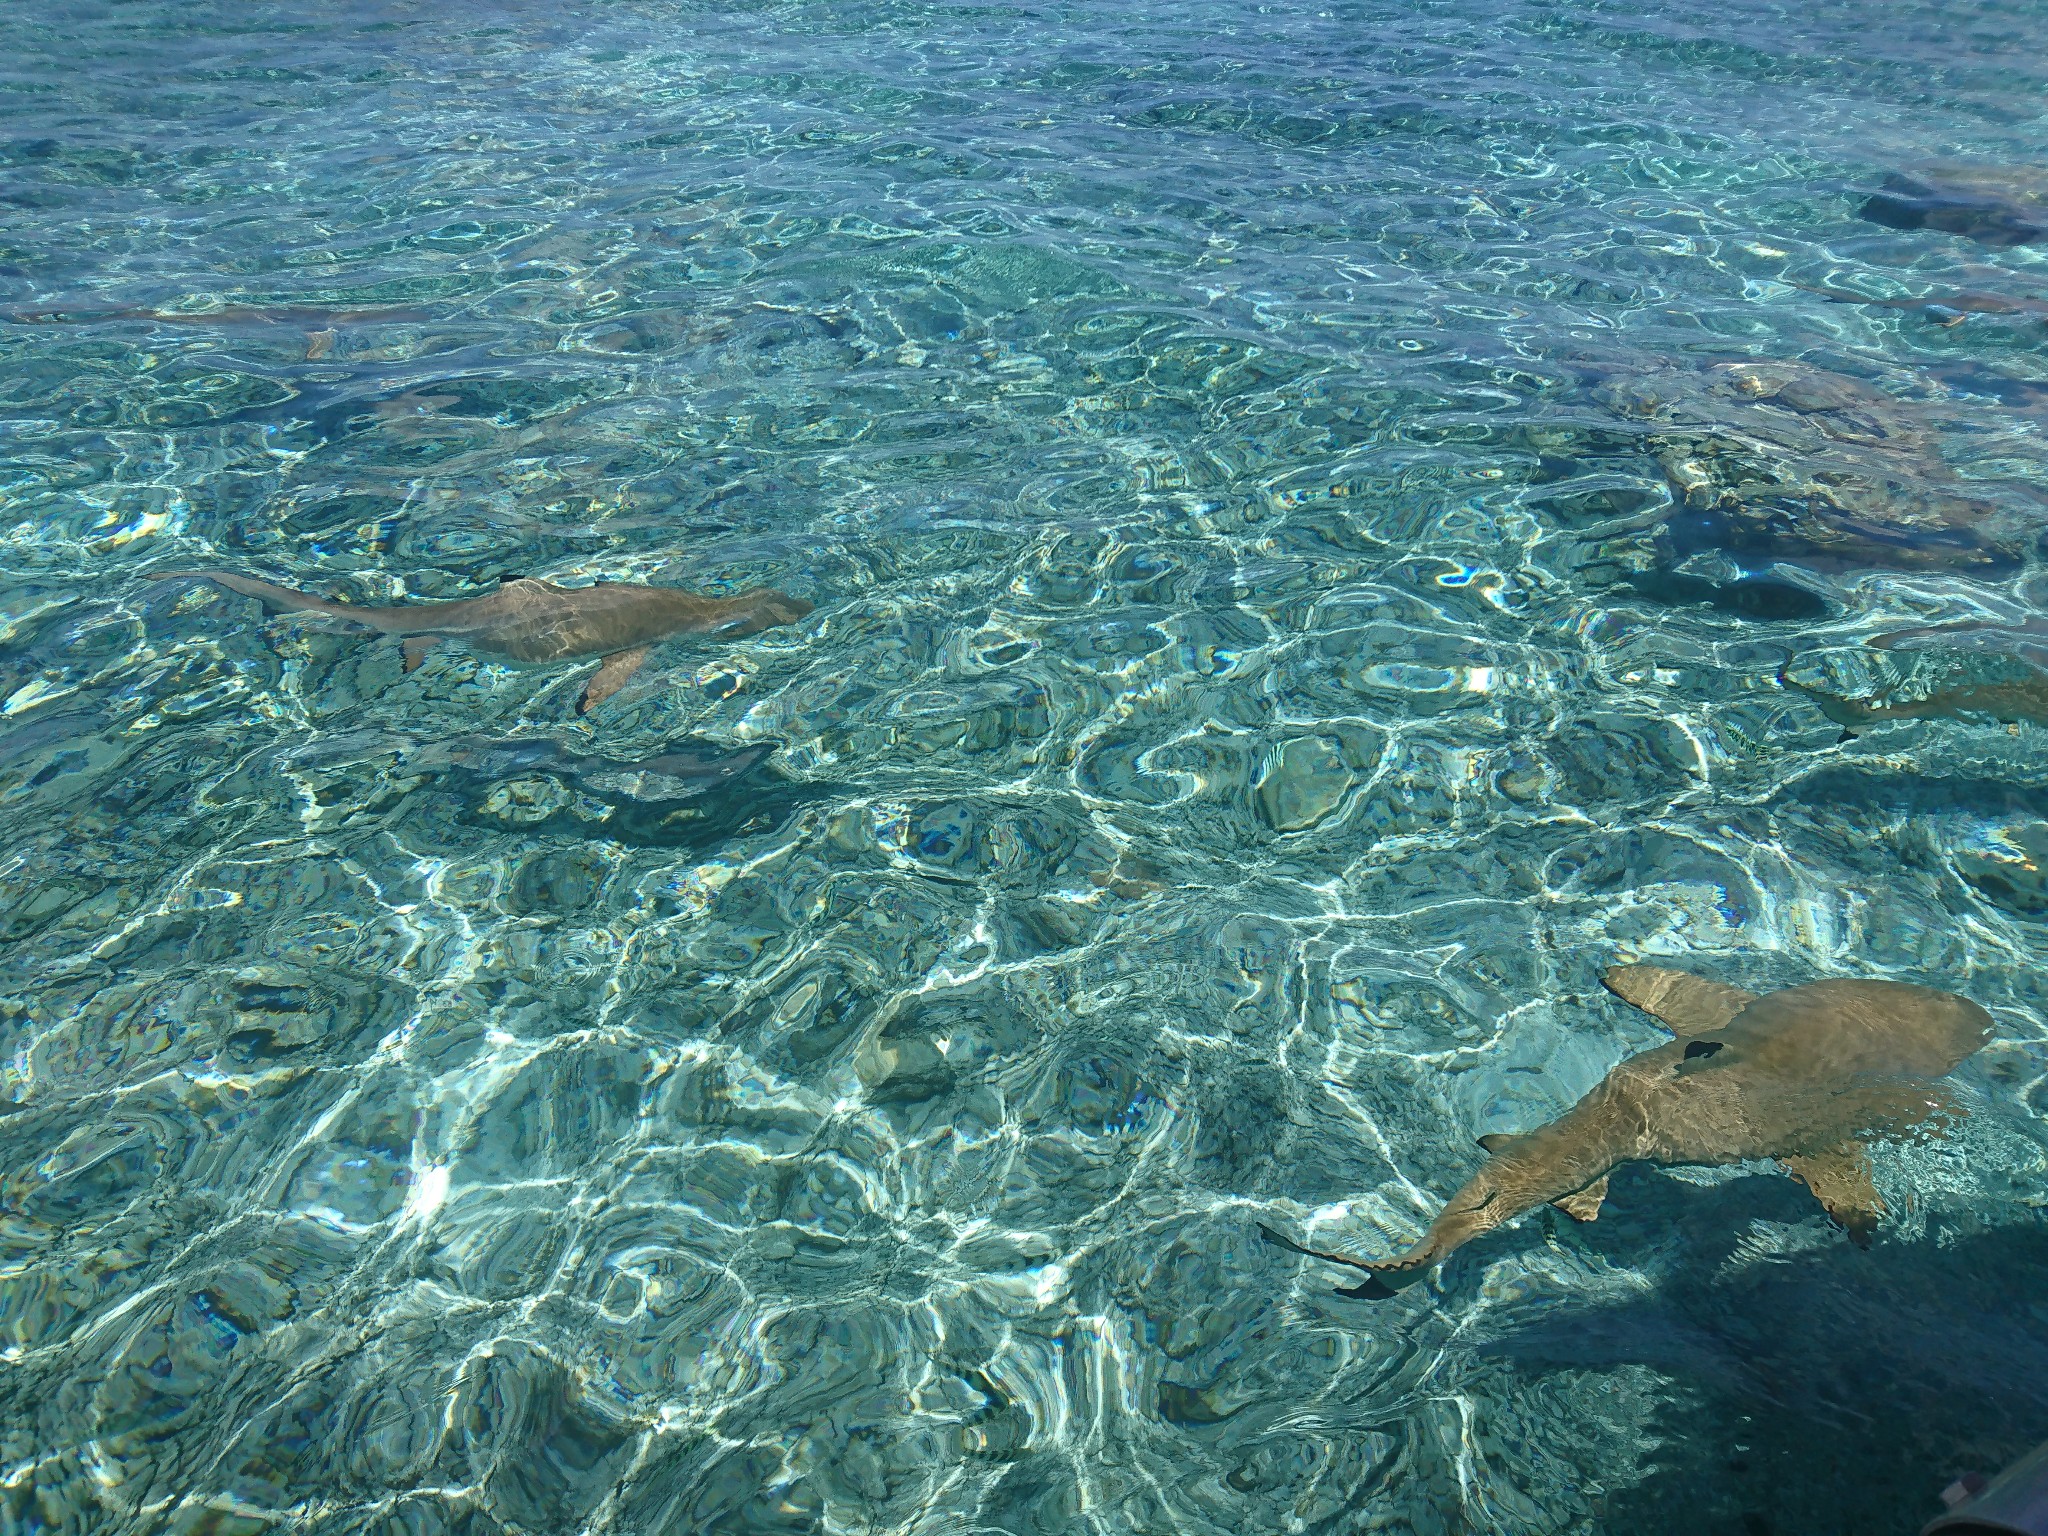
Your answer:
(1489, 1169), (2048, 1536)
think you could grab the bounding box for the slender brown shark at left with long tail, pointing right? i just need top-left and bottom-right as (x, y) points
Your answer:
(152, 571), (811, 713)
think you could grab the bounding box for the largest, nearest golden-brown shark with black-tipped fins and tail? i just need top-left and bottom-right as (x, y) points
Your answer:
(1260, 965), (1991, 1298)
